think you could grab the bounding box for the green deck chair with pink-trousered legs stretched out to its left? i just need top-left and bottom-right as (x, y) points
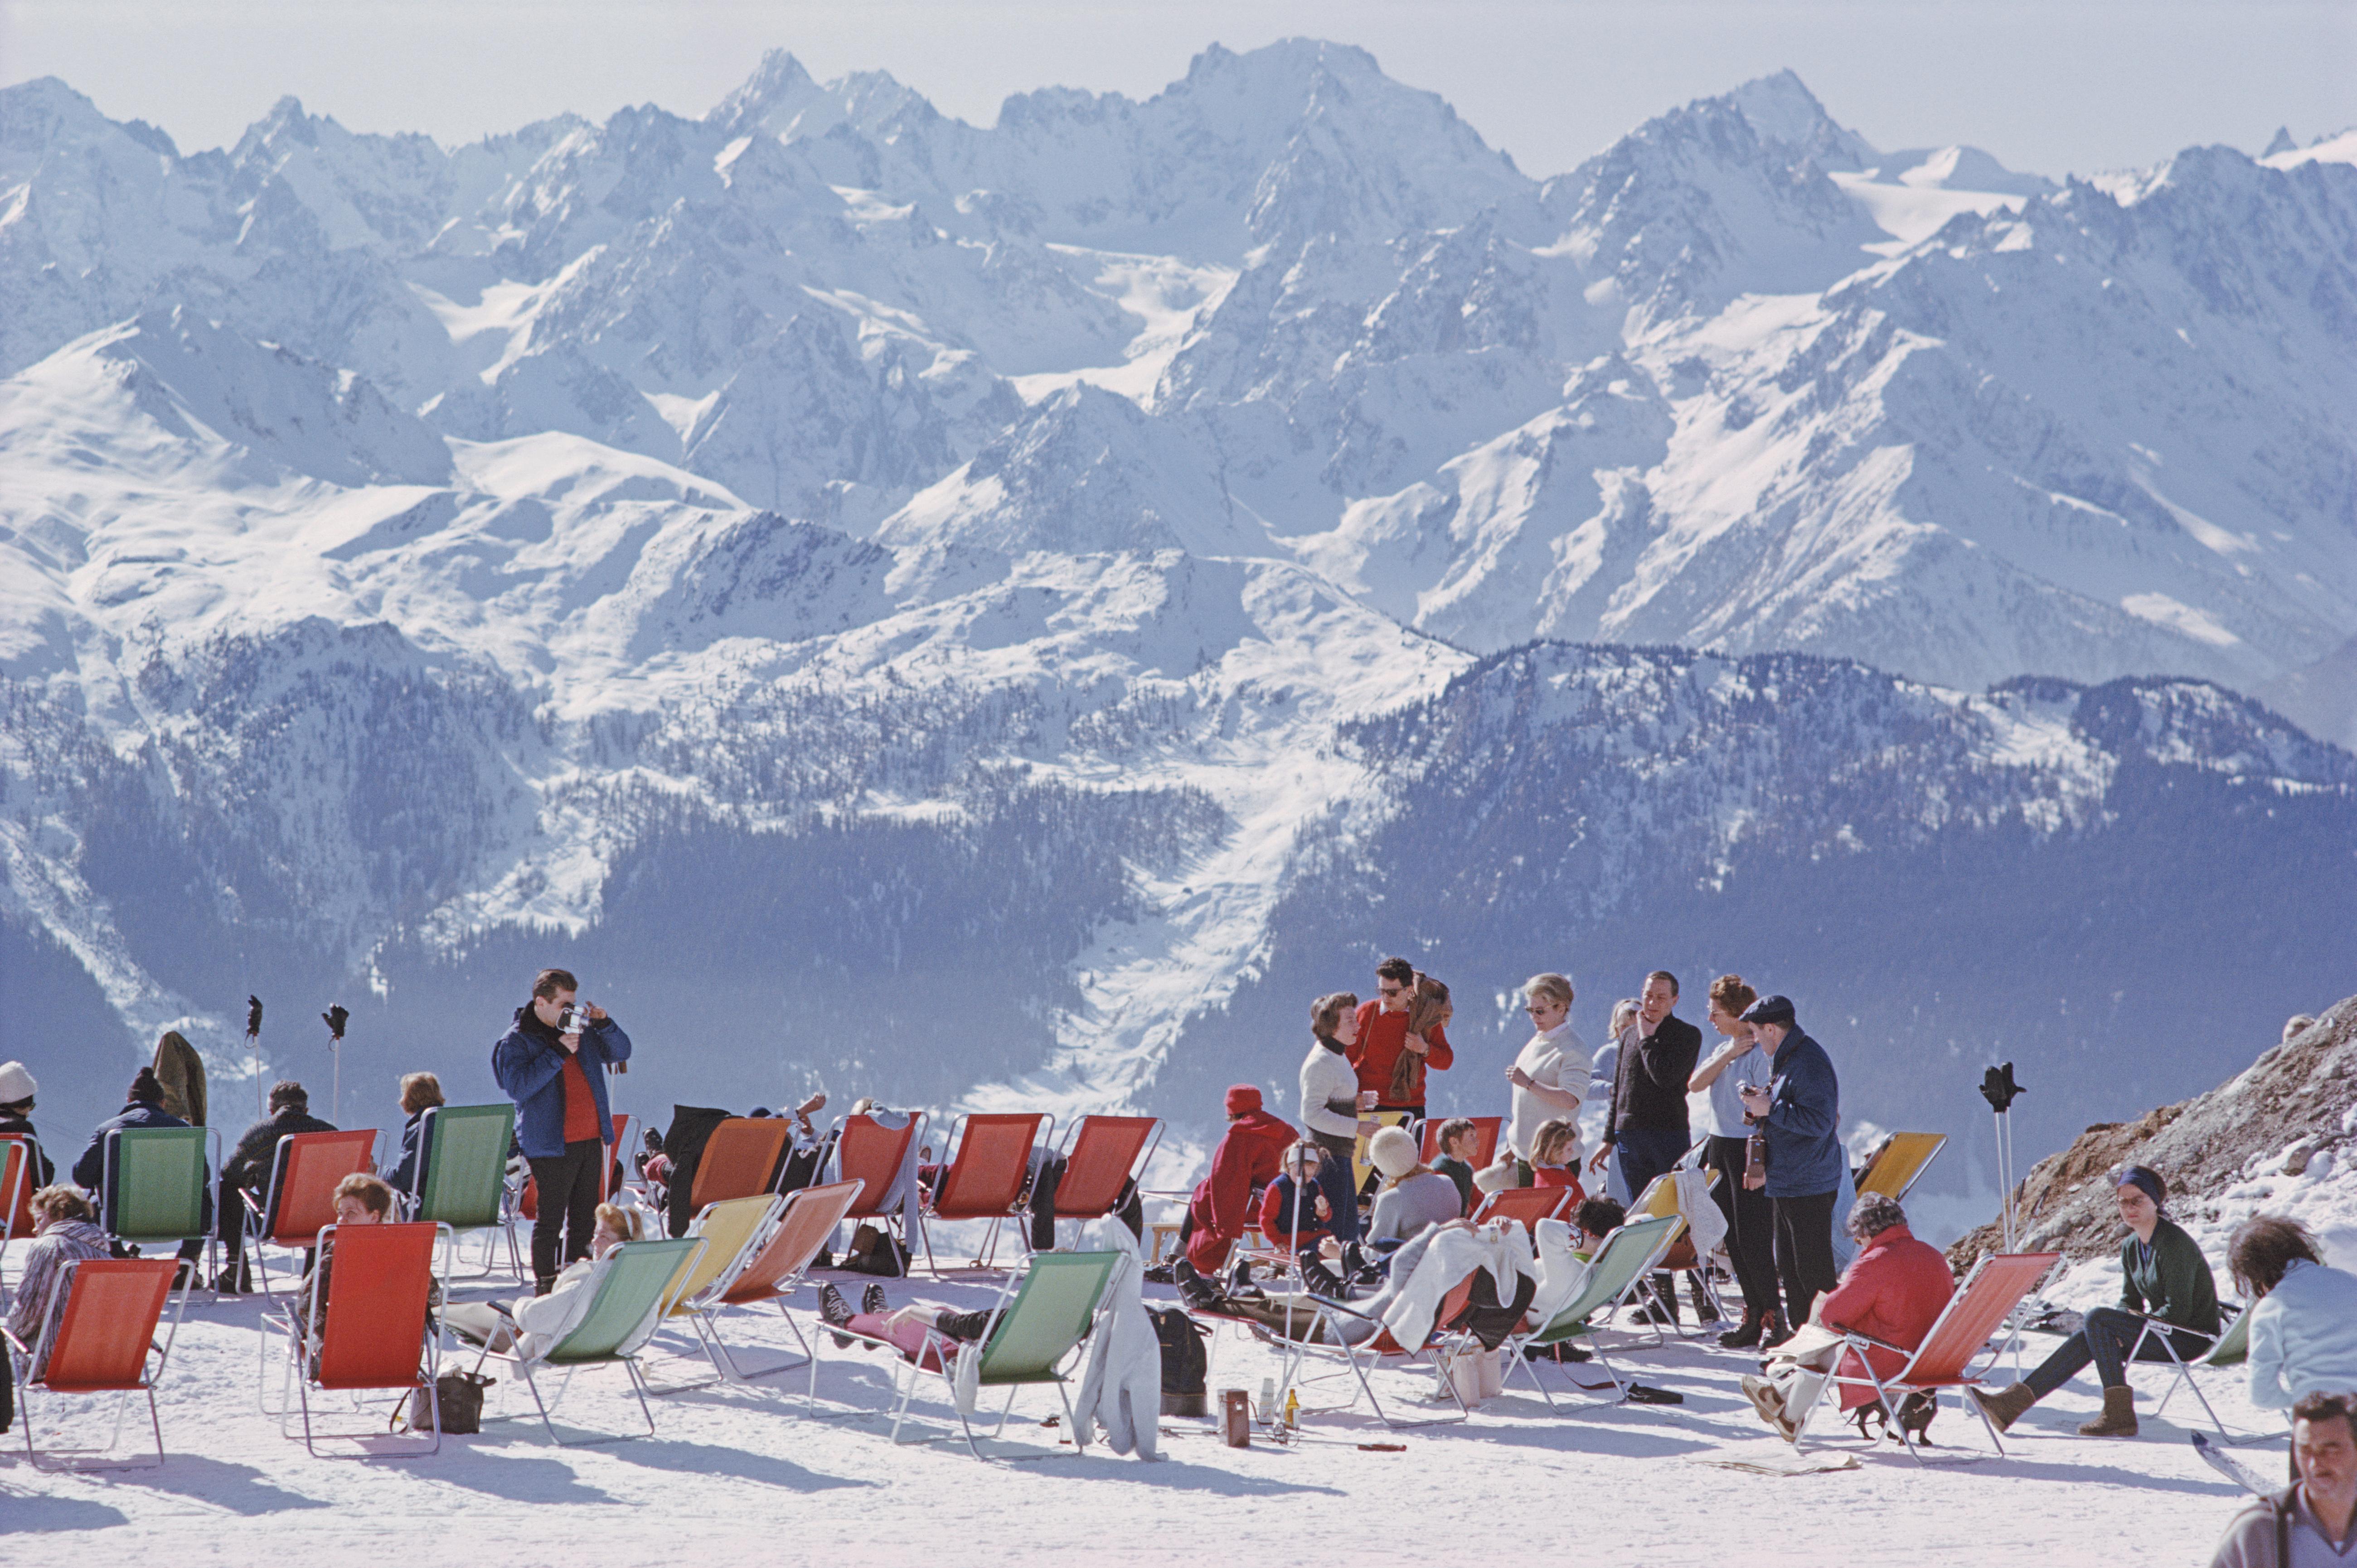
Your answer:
(844, 1252), (1124, 1460)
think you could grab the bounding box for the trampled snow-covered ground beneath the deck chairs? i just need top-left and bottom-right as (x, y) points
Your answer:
(0, 1167), (2357, 1566)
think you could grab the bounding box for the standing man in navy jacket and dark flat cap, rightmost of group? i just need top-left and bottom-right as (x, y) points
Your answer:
(1744, 997), (1841, 1335)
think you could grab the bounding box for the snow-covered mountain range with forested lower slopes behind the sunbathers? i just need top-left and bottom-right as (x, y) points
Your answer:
(0, 43), (2357, 1174)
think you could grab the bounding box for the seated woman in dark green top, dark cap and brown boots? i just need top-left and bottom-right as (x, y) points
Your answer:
(1966, 1165), (2218, 1438)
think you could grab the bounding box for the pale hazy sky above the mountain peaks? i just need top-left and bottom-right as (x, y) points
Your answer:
(0, 0), (2357, 175)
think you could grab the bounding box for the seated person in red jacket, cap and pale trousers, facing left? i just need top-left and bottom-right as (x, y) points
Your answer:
(1744, 1193), (1956, 1443)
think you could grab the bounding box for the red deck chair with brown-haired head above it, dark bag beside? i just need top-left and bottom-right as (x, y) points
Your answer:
(278, 1226), (443, 1460)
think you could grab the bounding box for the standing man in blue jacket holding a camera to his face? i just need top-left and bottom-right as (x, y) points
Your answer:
(490, 969), (629, 1295)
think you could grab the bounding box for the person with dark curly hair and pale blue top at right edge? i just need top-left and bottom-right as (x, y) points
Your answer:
(2227, 1214), (2357, 1443)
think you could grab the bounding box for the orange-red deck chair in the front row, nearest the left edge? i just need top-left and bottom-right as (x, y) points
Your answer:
(0, 1257), (189, 1469)
